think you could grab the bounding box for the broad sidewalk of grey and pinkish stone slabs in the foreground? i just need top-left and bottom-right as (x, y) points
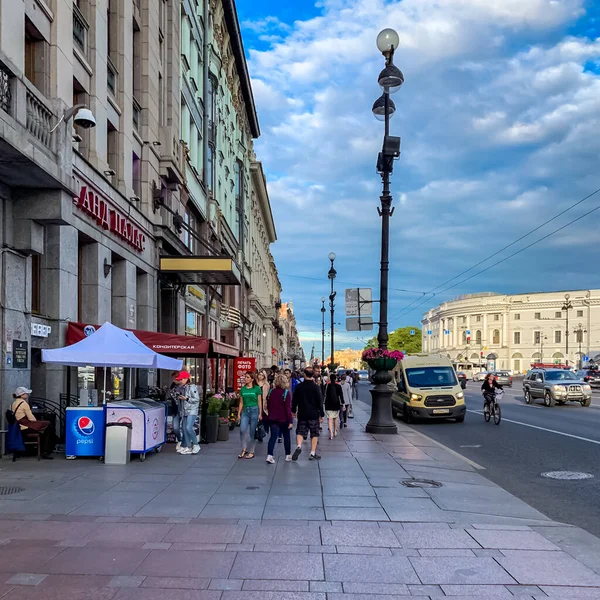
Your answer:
(0, 403), (600, 600)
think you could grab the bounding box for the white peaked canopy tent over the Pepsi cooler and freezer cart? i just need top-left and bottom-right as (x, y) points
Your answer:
(42, 322), (183, 402)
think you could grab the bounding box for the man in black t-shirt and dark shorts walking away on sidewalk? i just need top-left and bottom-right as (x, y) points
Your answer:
(292, 367), (325, 461)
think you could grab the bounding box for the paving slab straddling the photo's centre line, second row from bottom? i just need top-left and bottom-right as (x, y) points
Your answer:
(231, 552), (331, 580)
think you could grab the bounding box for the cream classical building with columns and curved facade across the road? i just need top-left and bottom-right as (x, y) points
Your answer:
(421, 290), (600, 372)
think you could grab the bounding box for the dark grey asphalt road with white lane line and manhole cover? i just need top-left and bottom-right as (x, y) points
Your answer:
(360, 379), (600, 536)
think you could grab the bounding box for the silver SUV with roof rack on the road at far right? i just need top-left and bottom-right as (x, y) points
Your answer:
(523, 369), (592, 406)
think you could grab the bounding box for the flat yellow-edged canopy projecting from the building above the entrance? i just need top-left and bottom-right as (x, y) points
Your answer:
(160, 256), (241, 285)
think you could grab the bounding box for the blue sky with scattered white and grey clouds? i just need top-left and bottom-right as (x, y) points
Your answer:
(237, 0), (600, 355)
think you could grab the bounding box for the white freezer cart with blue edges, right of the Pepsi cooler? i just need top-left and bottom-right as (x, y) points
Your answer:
(106, 399), (167, 461)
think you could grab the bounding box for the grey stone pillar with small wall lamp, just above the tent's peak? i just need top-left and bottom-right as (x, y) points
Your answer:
(80, 242), (112, 325)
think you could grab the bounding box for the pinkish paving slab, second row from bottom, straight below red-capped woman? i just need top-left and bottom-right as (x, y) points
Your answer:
(135, 549), (236, 579)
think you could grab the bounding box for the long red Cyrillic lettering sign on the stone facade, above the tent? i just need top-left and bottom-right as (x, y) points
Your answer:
(73, 173), (146, 252)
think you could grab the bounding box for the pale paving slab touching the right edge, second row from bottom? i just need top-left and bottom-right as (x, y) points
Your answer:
(494, 550), (600, 584)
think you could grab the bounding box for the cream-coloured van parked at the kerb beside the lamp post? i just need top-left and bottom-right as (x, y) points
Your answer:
(392, 355), (467, 423)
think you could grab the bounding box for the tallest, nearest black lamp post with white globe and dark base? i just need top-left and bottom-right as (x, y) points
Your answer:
(366, 29), (404, 433)
